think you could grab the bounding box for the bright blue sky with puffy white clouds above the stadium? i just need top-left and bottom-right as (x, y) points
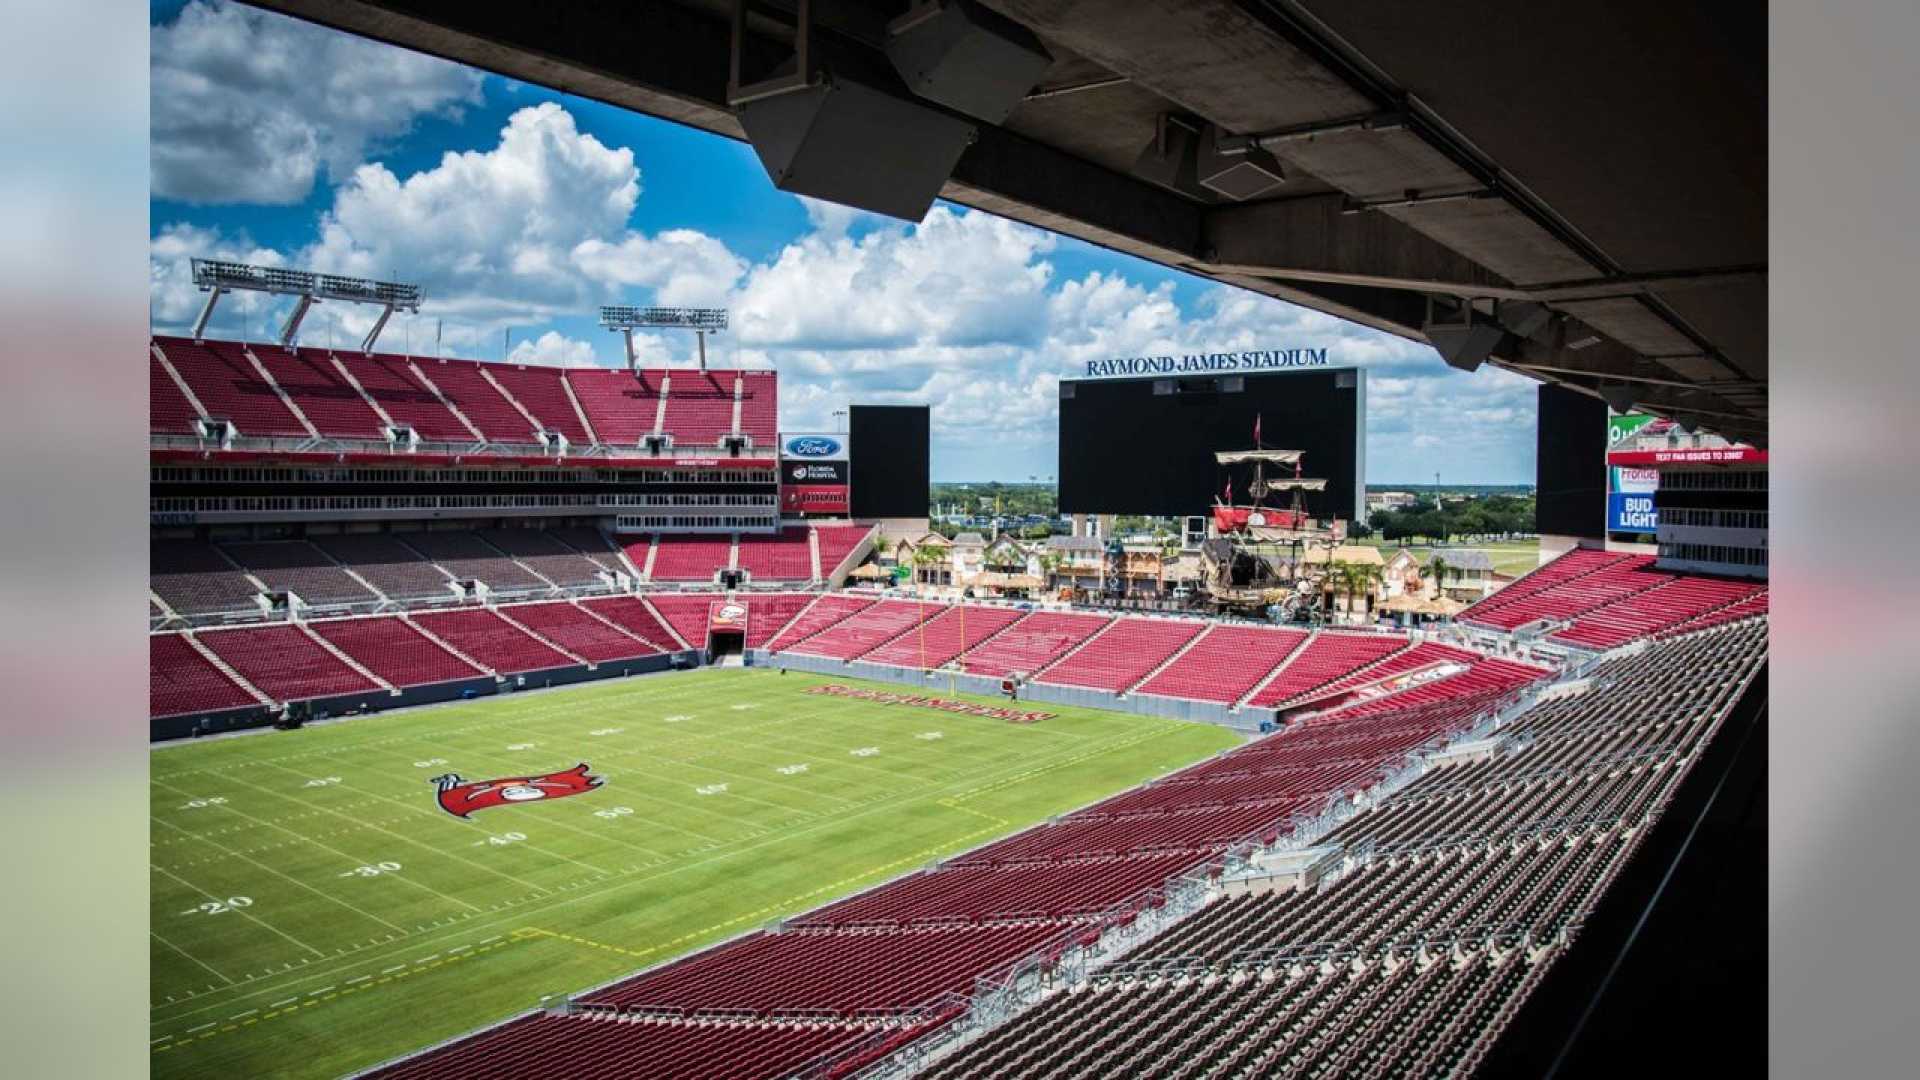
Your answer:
(152, 0), (1534, 484)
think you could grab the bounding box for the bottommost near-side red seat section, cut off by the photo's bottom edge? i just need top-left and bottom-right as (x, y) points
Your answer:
(369, 1013), (879, 1080)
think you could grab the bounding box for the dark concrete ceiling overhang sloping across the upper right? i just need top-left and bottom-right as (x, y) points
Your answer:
(240, 0), (1766, 442)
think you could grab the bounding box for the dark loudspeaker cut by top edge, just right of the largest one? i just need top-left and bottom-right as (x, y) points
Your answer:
(887, 0), (1054, 125)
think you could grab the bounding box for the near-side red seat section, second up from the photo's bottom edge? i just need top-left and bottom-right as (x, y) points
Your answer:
(582, 922), (1062, 1013)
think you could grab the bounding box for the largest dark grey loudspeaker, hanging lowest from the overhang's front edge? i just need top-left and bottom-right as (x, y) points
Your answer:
(739, 73), (973, 221)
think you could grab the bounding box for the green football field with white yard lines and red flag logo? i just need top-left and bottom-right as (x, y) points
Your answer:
(148, 669), (1236, 1076)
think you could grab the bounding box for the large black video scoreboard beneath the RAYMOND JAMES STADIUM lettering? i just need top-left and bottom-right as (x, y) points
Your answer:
(1060, 367), (1367, 521)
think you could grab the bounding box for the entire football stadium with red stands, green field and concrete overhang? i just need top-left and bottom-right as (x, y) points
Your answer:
(146, 0), (1768, 1080)
